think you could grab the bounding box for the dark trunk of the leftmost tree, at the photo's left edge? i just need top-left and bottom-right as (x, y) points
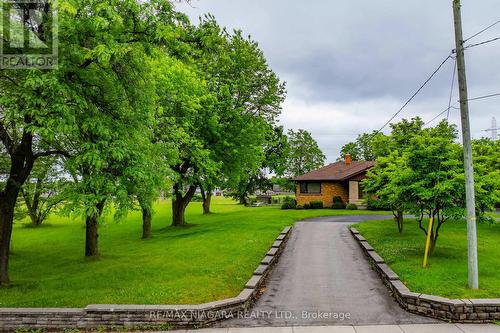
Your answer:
(0, 195), (15, 286)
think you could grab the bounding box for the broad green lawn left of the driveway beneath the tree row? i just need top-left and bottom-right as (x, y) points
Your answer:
(0, 198), (386, 307)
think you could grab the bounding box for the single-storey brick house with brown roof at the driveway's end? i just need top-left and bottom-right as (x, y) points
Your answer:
(293, 155), (375, 207)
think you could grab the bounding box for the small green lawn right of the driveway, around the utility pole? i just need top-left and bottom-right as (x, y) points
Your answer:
(356, 220), (500, 298)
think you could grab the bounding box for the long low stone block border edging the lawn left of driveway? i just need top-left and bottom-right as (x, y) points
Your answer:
(0, 227), (292, 332)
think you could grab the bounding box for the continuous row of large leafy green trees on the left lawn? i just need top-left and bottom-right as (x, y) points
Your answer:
(0, 0), (285, 284)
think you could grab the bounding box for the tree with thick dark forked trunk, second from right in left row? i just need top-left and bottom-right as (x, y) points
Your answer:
(154, 54), (215, 226)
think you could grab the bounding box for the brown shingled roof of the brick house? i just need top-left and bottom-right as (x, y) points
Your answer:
(292, 161), (375, 181)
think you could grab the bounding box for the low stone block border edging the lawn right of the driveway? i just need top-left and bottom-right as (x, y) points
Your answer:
(350, 228), (500, 323)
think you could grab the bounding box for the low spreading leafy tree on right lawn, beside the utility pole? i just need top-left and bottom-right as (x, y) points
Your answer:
(364, 118), (498, 253)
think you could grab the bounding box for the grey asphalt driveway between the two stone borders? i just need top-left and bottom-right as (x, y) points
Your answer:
(221, 215), (437, 327)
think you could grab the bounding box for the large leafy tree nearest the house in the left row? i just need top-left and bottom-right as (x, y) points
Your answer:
(191, 16), (285, 213)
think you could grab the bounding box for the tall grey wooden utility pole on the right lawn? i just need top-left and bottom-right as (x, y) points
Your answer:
(453, 0), (479, 289)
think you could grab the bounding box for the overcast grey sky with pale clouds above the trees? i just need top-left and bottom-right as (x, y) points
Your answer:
(177, 0), (500, 162)
